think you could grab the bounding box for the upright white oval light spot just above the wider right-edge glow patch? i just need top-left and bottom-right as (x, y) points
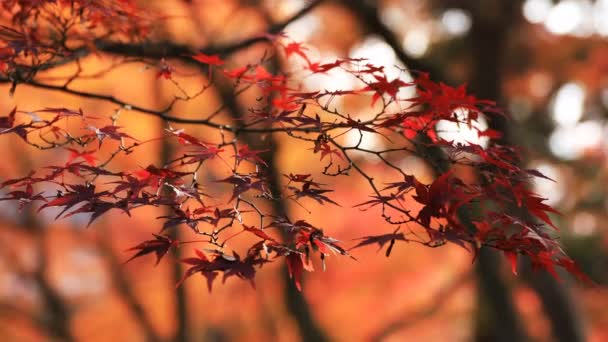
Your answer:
(552, 82), (585, 126)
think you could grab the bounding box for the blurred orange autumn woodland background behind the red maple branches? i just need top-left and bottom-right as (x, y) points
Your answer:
(0, 0), (608, 341)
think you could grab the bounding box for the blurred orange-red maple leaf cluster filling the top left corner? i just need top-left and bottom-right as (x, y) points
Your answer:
(0, 0), (151, 75)
